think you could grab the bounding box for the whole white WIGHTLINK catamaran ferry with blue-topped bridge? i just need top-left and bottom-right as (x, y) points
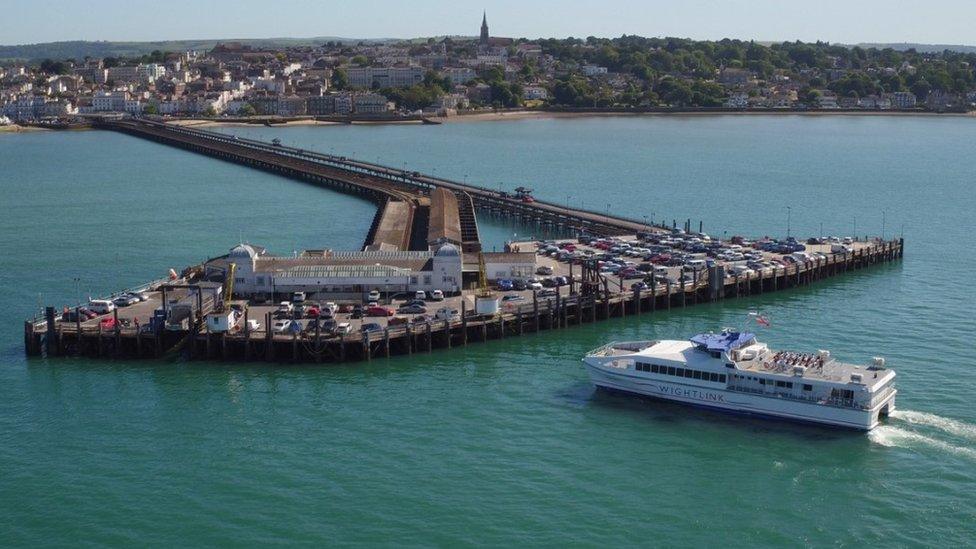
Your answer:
(583, 331), (897, 431)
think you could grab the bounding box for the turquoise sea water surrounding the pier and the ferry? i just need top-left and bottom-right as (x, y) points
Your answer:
(0, 116), (976, 547)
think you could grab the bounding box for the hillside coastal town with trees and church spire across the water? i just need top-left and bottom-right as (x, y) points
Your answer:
(0, 14), (976, 124)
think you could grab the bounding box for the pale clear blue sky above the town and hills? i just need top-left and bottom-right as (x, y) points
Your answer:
(7, 0), (976, 44)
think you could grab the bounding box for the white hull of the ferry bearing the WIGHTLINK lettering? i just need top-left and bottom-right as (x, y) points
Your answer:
(584, 360), (896, 431)
